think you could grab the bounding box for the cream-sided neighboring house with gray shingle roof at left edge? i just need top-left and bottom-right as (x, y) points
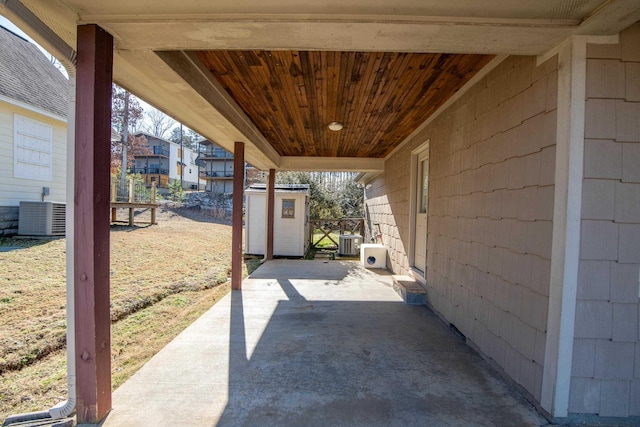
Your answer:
(0, 27), (69, 235)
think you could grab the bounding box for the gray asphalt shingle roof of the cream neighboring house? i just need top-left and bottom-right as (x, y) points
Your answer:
(0, 26), (69, 117)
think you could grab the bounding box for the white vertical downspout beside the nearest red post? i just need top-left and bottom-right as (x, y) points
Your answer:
(49, 69), (76, 420)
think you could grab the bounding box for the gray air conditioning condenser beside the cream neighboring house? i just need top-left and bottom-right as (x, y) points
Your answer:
(18, 201), (66, 236)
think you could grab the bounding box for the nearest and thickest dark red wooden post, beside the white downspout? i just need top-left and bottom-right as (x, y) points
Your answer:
(73, 24), (113, 424)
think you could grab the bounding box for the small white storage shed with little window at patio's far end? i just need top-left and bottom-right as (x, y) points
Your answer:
(245, 184), (309, 257)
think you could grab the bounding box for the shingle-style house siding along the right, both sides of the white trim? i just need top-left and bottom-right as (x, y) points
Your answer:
(365, 24), (640, 417)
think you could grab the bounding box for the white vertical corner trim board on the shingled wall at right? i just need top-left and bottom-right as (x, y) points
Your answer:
(540, 36), (587, 417)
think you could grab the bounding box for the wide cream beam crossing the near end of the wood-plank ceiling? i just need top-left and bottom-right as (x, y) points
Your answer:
(101, 16), (578, 55)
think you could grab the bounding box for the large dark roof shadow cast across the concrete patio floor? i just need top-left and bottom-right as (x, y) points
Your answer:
(217, 261), (544, 426)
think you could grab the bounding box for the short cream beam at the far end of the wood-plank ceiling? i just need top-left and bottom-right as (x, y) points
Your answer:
(278, 156), (384, 172)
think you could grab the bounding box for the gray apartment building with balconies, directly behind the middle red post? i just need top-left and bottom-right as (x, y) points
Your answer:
(198, 139), (264, 194)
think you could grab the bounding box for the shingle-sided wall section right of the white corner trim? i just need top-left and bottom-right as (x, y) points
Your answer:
(569, 25), (640, 417)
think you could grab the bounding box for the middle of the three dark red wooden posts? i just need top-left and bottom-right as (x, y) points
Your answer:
(231, 142), (244, 290)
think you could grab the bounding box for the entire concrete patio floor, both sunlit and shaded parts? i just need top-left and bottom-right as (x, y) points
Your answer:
(103, 260), (547, 427)
